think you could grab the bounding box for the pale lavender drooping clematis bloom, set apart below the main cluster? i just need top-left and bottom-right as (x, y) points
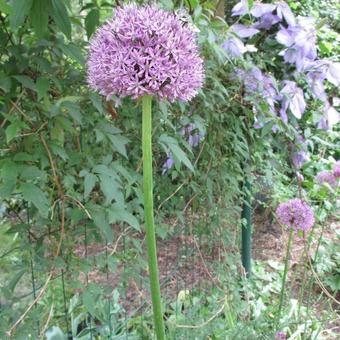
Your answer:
(280, 80), (306, 123)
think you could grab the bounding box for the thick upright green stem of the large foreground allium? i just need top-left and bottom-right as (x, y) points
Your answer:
(142, 95), (165, 340)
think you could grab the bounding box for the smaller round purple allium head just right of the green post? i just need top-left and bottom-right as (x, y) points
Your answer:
(276, 198), (314, 231)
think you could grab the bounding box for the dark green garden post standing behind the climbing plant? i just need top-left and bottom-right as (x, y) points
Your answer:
(241, 180), (252, 276)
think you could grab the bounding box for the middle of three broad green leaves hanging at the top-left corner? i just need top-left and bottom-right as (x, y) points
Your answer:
(30, 0), (51, 38)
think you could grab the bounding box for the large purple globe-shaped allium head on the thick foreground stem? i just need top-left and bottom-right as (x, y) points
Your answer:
(87, 5), (204, 101)
